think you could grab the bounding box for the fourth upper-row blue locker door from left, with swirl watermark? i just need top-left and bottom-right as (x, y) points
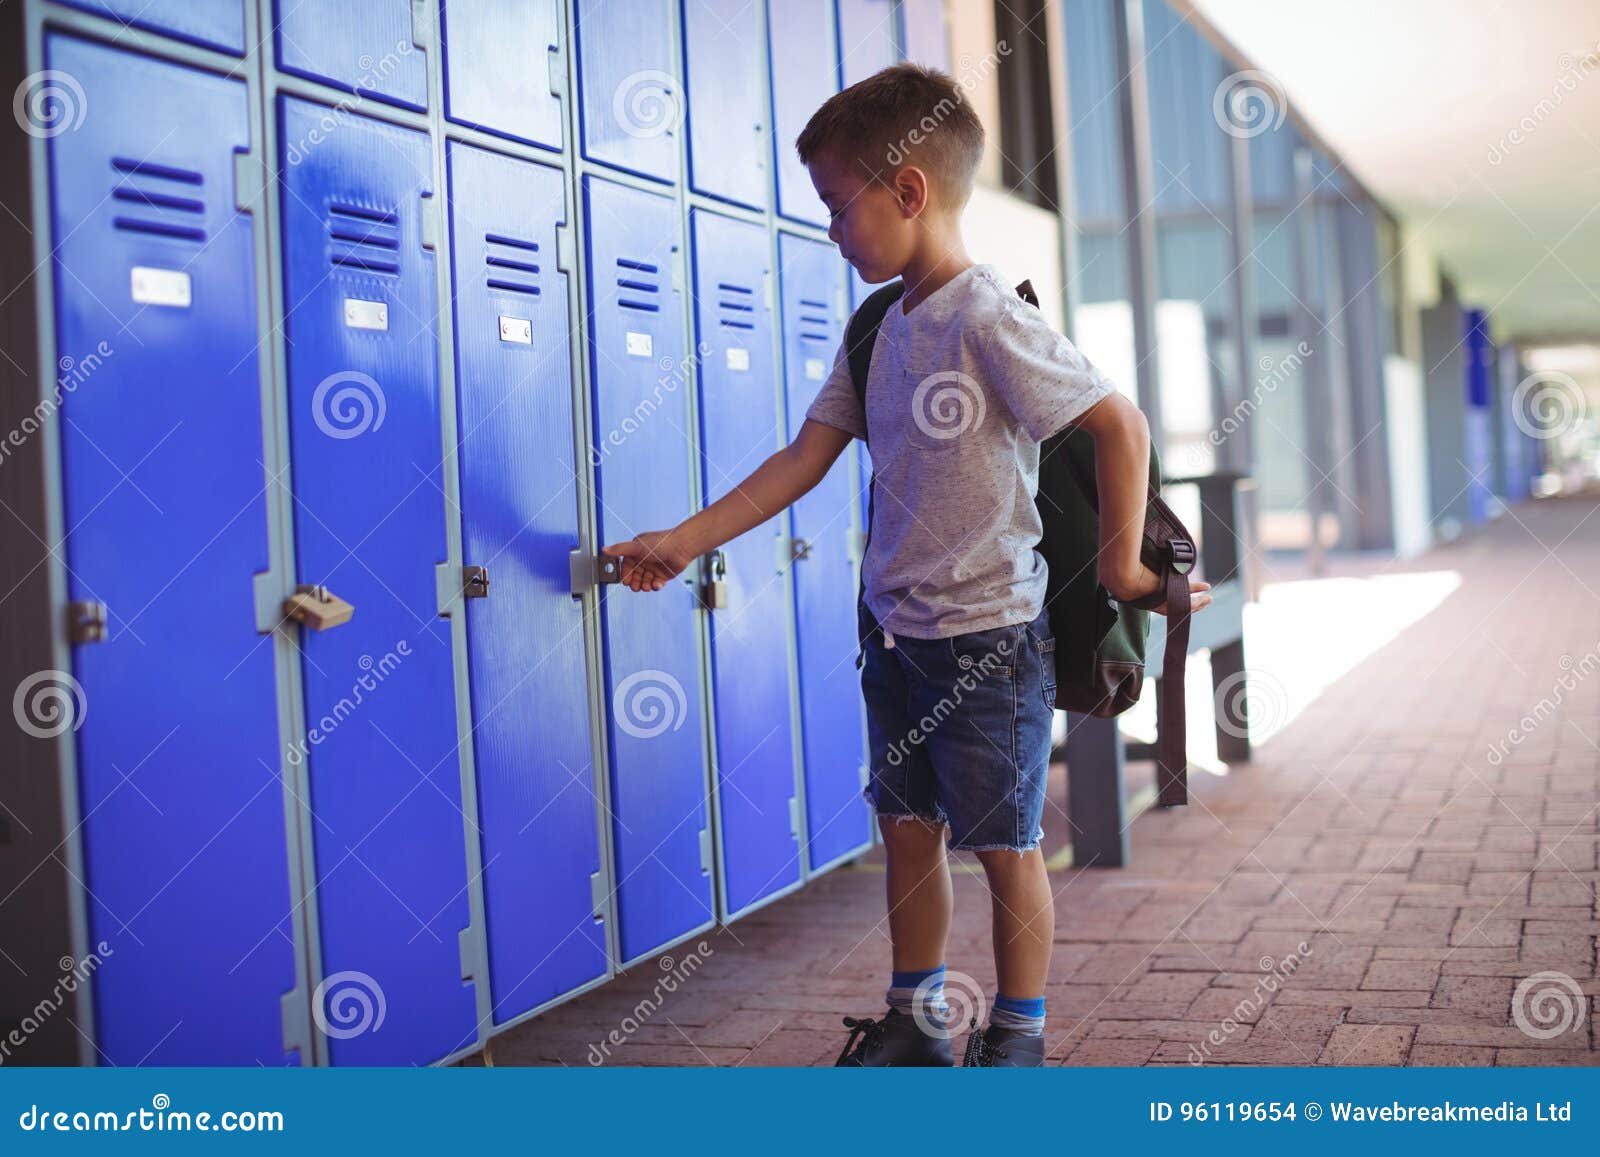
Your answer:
(576, 0), (683, 182)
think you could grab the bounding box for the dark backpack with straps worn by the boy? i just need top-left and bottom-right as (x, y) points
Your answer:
(845, 282), (1197, 807)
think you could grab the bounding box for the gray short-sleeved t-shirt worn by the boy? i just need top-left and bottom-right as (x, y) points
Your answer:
(806, 264), (1115, 639)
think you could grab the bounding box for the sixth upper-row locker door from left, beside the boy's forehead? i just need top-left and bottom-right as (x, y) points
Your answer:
(766, 0), (838, 226)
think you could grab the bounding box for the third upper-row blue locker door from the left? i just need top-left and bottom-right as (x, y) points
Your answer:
(440, 0), (565, 149)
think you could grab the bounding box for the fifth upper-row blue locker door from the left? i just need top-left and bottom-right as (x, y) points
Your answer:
(683, 0), (768, 208)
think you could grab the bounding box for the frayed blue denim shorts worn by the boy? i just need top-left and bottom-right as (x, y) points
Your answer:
(859, 607), (1056, 851)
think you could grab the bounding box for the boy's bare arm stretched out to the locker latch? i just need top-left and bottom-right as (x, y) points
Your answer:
(600, 418), (853, 591)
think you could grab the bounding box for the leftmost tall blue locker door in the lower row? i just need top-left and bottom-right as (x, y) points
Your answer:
(46, 35), (301, 1064)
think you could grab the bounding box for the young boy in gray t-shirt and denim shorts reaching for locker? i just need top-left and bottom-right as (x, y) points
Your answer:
(603, 64), (1210, 1066)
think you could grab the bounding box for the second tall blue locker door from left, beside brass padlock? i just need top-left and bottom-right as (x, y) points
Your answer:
(278, 98), (477, 1064)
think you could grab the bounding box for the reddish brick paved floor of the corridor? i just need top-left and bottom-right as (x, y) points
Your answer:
(467, 494), (1600, 1066)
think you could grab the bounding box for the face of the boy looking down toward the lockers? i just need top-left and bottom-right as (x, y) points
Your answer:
(806, 154), (926, 285)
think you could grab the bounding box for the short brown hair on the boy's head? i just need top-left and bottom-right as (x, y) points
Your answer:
(795, 62), (984, 210)
